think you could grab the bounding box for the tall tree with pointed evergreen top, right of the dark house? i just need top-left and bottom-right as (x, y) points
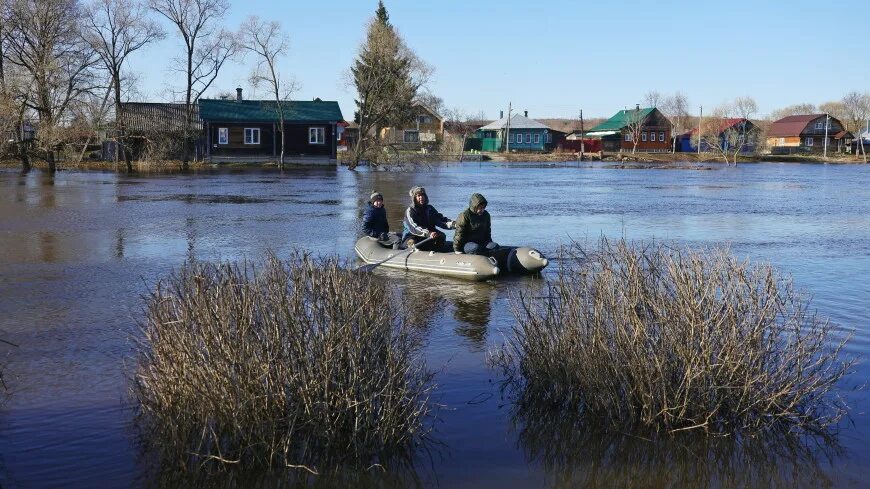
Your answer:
(349, 2), (432, 168)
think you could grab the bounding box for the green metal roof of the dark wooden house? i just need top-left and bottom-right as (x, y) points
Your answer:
(199, 99), (344, 122)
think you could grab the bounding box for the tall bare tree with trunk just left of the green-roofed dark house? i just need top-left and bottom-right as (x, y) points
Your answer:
(149, 0), (238, 171)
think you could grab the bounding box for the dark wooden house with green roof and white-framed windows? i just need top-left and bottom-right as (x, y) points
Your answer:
(199, 89), (344, 163)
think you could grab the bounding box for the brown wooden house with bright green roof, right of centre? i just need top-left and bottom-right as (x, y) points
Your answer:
(584, 106), (672, 153)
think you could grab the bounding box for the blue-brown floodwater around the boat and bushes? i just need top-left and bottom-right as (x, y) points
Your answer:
(0, 163), (870, 489)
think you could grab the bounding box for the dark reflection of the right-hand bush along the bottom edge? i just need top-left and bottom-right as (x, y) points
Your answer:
(513, 401), (841, 488)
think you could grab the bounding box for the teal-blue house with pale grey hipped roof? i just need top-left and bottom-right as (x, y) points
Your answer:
(477, 112), (555, 152)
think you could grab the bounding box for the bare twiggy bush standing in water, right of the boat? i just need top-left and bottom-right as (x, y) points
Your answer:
(492, 240), (854, 434)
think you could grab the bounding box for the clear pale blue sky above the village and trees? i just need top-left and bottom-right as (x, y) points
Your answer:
(131, 0), (870, 118)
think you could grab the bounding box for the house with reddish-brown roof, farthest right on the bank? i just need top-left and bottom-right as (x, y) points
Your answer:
(767, 114), (854, 154)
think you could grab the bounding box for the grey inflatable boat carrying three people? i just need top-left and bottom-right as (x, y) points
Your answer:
(354, 236), (549, 281)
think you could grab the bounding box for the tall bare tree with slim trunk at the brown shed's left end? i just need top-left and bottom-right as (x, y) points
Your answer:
(83, 0), (164, 173)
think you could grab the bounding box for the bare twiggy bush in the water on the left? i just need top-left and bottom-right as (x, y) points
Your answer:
(133, 255), (432, 472)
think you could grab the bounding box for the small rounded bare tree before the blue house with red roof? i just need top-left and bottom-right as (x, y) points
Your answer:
(698, 97), (760, 166)
